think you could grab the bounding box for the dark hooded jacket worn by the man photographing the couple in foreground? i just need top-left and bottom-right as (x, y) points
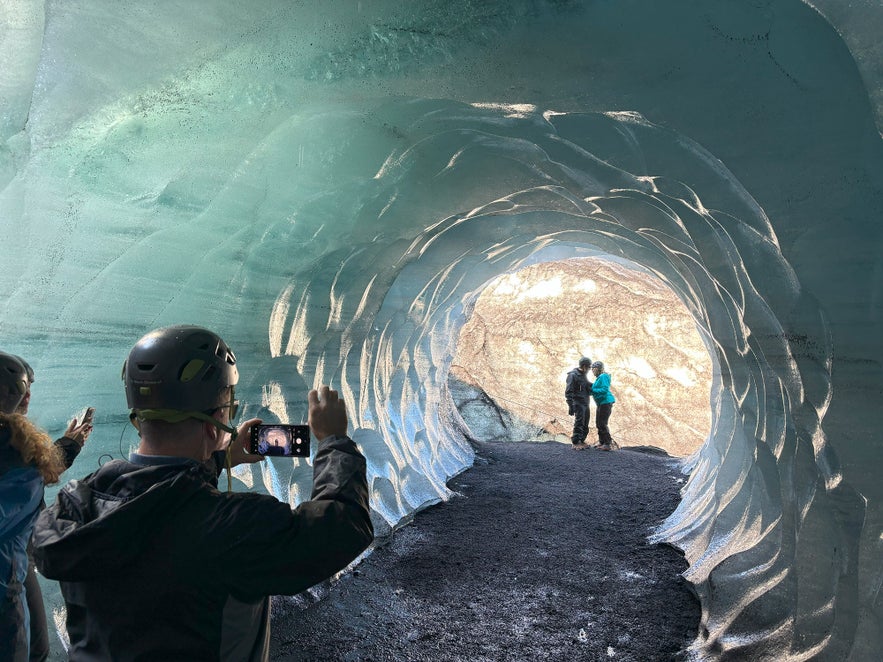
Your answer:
(34, 437), (373, 662)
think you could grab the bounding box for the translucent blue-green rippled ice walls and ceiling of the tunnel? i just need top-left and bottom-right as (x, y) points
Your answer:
(0, 0), (883, 660)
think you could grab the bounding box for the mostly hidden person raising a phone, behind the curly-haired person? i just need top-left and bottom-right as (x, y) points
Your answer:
(12, 355), (95, 662)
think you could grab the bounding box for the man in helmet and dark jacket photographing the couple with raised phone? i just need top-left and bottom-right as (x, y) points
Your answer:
(34, 326), (373, 662)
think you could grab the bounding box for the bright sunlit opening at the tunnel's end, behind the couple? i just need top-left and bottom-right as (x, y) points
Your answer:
(449, 257), (713, 457)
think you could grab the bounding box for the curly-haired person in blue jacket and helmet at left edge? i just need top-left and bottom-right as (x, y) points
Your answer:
(0, 352), (64, 662)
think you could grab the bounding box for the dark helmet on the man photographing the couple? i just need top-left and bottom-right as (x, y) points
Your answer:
(123, 325), (239, 412)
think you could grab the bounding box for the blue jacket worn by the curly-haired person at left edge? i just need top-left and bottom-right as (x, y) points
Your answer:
(0, 426), (43, 659)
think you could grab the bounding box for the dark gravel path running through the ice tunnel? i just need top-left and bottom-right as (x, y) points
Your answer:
(272, 442), (699, 662)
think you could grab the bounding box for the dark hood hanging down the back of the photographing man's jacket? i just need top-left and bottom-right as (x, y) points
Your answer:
(34, 460), (211, 581)
